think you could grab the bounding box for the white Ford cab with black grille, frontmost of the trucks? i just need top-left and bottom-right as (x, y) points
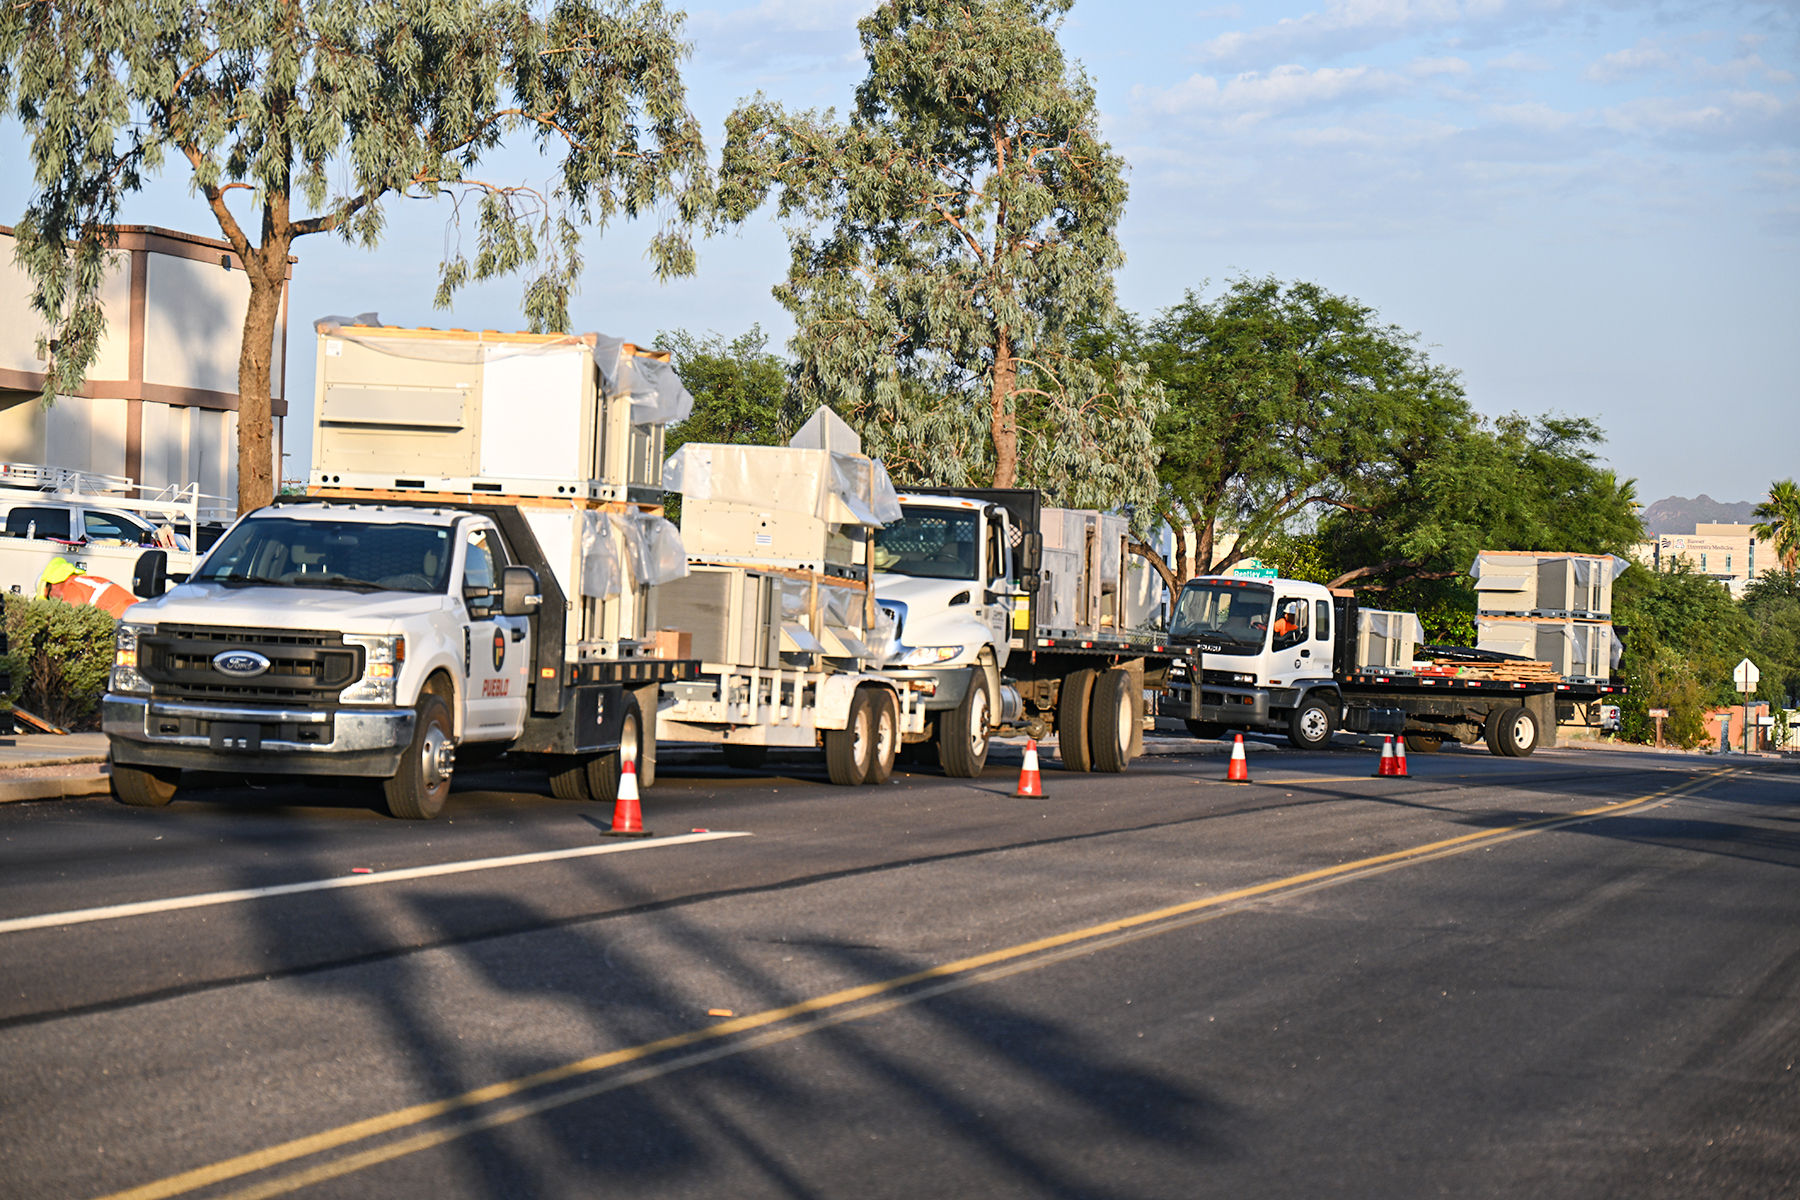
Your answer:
(103, 504), (538, 817)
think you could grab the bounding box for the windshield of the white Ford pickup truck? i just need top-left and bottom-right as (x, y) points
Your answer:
(194, 516), (454, 592)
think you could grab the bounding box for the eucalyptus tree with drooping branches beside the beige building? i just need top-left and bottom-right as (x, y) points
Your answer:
(0, 0), (711, 511)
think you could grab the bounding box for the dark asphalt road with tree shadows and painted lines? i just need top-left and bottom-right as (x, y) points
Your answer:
(0, 743), (1800, 1200)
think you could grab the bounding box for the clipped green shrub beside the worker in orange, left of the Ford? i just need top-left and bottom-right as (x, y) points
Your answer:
(5, 596), (117, 725)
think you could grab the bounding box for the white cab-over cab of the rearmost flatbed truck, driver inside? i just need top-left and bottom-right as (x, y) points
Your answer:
(1163, 576), (1343, 748)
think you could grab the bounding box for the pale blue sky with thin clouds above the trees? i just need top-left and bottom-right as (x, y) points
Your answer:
(0, 0), (1800, 500)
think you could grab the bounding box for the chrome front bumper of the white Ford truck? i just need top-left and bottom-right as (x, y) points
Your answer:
(101, 693), (416, 779)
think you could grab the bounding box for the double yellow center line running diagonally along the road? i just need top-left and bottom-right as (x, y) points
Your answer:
(101, 768), (1730, 1200)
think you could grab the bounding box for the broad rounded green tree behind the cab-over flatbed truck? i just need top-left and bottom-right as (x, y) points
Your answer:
(1108, 279), (1472, 574)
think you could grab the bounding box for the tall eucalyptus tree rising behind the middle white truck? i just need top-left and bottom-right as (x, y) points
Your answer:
(718, 0), (1159, 518)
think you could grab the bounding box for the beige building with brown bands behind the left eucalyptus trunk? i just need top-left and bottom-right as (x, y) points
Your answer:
(0, 225), (292, 506)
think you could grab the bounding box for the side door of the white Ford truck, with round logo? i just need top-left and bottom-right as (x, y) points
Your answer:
(463, 525), (531, 741)
